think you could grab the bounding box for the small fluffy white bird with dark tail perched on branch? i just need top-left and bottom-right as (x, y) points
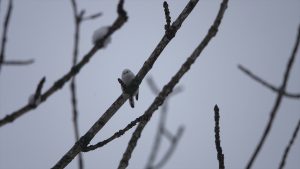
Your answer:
(119, 69), (139, 108)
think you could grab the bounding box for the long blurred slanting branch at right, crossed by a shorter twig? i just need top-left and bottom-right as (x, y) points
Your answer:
(246, 25), (300, 169)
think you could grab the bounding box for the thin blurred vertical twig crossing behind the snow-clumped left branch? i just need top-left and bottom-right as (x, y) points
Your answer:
(70, 0), (84, 169)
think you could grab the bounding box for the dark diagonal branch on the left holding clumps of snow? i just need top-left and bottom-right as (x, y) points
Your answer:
(0, 0), (127, 127)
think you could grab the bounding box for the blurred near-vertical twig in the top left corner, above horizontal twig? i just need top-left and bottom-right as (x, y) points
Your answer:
(0, 0), (13, 71)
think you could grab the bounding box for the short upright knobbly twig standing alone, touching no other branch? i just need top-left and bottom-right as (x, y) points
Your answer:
(214, 105), (225, 169)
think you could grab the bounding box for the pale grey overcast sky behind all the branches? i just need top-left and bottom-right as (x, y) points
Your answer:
(0, 0), (300, 169)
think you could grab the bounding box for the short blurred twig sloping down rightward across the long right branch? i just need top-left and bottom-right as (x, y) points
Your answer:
(238, 65), (300, 99)
